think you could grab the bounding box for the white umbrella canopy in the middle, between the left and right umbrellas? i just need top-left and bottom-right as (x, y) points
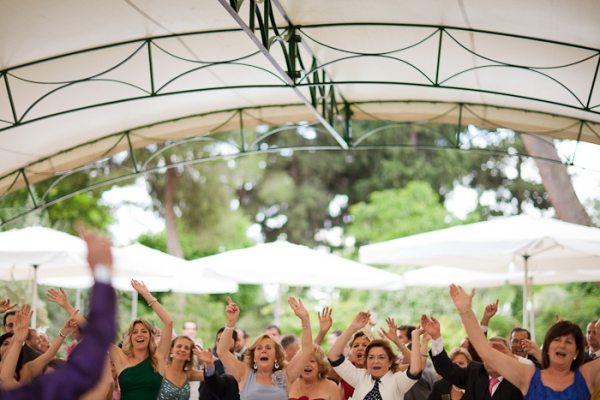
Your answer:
(191, 241), (403, 290)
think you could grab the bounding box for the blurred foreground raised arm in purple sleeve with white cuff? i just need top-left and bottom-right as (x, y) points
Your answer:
(0, 230), (116, 400)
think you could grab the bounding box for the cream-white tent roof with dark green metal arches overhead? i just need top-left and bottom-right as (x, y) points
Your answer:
(0, 0), (600, 216)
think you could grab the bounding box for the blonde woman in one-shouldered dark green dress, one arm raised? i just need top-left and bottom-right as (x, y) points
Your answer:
(109, 280), (173, 400)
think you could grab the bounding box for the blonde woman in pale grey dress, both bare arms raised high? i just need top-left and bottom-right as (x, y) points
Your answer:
(217, 297), (313, 400)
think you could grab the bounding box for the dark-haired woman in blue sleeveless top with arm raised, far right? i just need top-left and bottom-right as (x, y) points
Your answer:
(450, 285), (600, 400)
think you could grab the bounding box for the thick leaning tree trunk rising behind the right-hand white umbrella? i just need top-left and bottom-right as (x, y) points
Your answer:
(521, 135), (594, 226)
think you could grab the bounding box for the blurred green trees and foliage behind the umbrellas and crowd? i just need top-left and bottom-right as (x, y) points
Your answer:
(0, 121), (600, 356)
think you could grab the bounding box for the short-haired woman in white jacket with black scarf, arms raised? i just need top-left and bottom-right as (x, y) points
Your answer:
(327, 311), (423, 400)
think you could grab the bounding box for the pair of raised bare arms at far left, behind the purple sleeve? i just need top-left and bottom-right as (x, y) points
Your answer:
(0, 304), (78, 390)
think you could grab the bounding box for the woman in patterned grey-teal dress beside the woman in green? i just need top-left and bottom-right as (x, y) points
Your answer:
(158, 335), (204, 400)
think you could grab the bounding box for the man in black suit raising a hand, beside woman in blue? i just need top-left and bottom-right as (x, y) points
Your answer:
(421, 316), (523, 400)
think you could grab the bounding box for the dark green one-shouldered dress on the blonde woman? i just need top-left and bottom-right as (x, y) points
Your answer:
(119, 357), (163, 400)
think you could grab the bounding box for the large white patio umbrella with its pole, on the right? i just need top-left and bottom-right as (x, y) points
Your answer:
(359, 215), (600, 334)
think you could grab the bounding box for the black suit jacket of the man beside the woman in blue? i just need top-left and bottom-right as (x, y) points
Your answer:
(429, 350), (523, 400)
